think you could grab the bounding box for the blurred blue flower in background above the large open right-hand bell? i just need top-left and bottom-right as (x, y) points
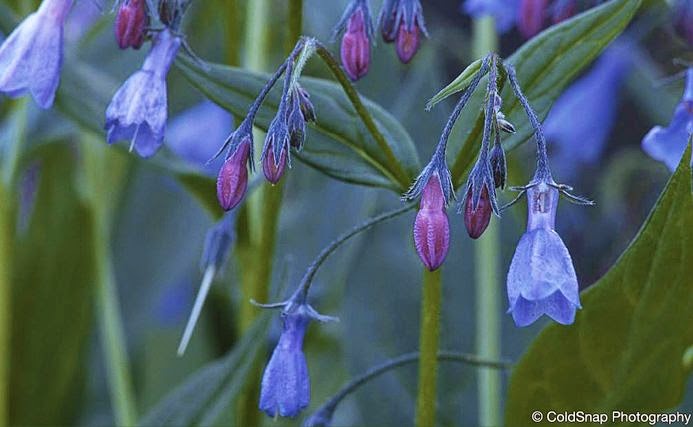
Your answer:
(544, 41), (632, 179)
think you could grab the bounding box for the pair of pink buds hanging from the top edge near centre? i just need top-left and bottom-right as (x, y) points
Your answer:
(334, 0), (428, 81)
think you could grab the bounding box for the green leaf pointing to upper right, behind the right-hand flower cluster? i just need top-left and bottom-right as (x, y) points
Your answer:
(448, 0), (640, 186)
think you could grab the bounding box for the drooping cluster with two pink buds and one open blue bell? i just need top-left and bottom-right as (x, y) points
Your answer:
(403, 54), (592, 326)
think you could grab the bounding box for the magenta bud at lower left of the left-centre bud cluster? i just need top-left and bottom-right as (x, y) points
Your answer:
(217, 141), (250, 211)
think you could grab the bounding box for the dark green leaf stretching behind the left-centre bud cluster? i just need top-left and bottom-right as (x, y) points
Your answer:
(176, 57), (420, 192)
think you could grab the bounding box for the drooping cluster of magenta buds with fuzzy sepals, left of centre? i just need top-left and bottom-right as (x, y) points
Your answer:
(214, 39), (316, 211)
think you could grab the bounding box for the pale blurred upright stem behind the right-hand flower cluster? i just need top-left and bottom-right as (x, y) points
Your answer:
(473, 16), (502, 427)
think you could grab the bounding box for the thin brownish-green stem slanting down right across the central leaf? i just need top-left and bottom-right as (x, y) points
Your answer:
(316, 41), (411, 191)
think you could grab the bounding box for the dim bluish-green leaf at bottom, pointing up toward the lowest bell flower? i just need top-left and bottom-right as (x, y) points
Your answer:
(139, 312), (272, 426)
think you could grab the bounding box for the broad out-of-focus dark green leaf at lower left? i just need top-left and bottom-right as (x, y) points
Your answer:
(10, 144), (95, 425)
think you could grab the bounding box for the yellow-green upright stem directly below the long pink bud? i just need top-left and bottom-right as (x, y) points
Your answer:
(416, 269), (441, 427)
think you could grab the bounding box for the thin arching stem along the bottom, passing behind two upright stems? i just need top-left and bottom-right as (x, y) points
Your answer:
(311, 351), (511, 426)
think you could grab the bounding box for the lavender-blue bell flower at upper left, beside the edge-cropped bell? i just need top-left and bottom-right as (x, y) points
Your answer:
(105, 29), (181, 157)
